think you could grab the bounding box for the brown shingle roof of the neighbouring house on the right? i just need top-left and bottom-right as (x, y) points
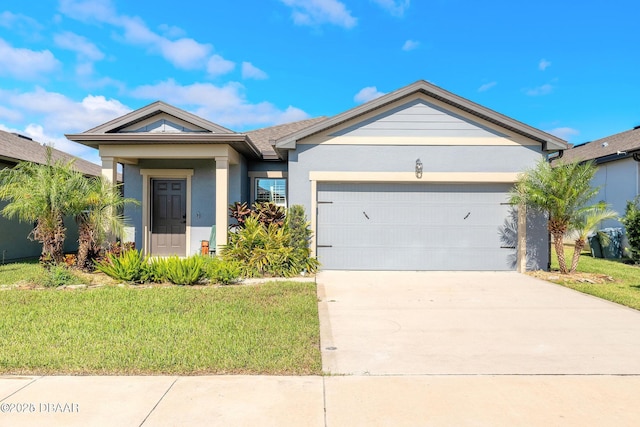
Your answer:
(562, 127), (640, 161)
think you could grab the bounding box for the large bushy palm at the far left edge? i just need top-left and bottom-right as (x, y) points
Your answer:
(0, 147), (85, 263)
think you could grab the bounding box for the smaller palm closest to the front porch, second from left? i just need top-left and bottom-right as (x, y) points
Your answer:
(76, 177), (137, 270)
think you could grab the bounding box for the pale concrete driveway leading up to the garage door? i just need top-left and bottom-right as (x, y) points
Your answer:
(317, 271), (640, 375)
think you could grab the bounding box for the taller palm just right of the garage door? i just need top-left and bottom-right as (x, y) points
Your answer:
(510, 159), (598, 274)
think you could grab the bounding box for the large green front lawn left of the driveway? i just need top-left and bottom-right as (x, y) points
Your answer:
(0, 282), (321, 375)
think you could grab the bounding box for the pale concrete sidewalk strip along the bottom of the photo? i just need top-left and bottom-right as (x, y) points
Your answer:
(0, 375), (640, 427)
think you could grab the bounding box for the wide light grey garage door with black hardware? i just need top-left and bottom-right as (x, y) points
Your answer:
(316, 183), (517, 270)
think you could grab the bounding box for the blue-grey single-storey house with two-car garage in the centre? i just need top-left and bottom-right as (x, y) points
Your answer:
(67, 81), (567, 270)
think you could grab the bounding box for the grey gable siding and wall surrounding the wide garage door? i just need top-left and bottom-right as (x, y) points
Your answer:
(288, 94), (548, 269)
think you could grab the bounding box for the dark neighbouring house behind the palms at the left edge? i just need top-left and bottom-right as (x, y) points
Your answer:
(0, 130), (101, 263)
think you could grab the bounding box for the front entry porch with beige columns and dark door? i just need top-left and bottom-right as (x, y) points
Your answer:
(100, 144), (244, 256)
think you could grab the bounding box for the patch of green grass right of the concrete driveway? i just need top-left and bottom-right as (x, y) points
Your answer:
(551, 247), (640, 310)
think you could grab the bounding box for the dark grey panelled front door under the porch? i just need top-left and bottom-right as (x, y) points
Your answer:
(151, 179), (187, 256)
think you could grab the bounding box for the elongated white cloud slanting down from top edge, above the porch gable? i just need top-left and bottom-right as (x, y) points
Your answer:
(60, 0), (218, 70)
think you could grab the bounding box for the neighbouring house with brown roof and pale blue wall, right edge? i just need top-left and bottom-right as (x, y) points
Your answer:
(554, 126), (640, 227)
